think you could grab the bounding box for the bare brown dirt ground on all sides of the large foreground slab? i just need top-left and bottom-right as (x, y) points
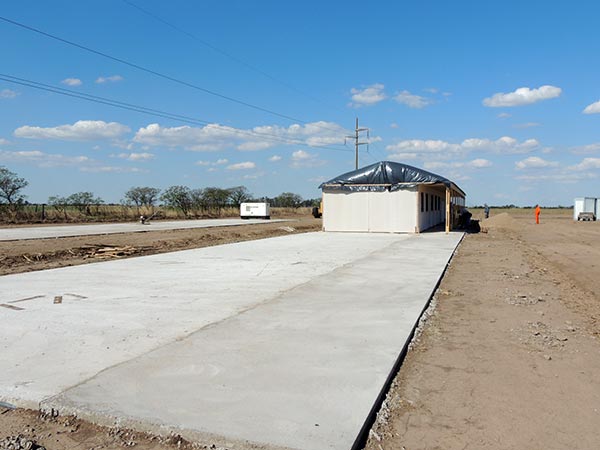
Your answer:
(0, 210), (600, 450)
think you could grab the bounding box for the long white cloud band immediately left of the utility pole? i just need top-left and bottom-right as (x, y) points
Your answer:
(133, 121), (349, 152)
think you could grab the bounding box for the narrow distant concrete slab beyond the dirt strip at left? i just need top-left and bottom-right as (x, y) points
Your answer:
(0, 219), (286, 241)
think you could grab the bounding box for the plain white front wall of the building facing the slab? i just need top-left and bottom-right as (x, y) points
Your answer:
(323, 188), (418, 233)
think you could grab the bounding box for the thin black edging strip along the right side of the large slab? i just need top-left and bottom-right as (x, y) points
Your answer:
(350, 233), (466, 450)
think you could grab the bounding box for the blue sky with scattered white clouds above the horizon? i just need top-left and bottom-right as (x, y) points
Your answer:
(0, 0), (600, 205)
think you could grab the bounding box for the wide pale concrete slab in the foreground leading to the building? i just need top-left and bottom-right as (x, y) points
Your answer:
(0, 233), (462, 450)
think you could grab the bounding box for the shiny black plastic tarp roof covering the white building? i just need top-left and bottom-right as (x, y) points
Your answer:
(319, 161), (465, 195)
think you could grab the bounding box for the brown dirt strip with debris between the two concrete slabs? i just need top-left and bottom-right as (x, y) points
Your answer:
(0, 216), (321, 275)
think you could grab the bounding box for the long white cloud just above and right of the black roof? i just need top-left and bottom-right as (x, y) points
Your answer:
(386, 136), (540, 160)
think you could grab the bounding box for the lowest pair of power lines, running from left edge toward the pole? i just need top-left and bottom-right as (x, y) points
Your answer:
(0, 73), (351, 152)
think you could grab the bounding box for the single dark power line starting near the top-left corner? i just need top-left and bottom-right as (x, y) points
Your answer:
(0, 16), (346, 136)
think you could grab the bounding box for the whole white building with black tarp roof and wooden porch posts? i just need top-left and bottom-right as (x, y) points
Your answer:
(320, 161), (465, 233)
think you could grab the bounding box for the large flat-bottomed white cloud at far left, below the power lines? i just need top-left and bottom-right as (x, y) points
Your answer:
(14, 120), (131, 141)
